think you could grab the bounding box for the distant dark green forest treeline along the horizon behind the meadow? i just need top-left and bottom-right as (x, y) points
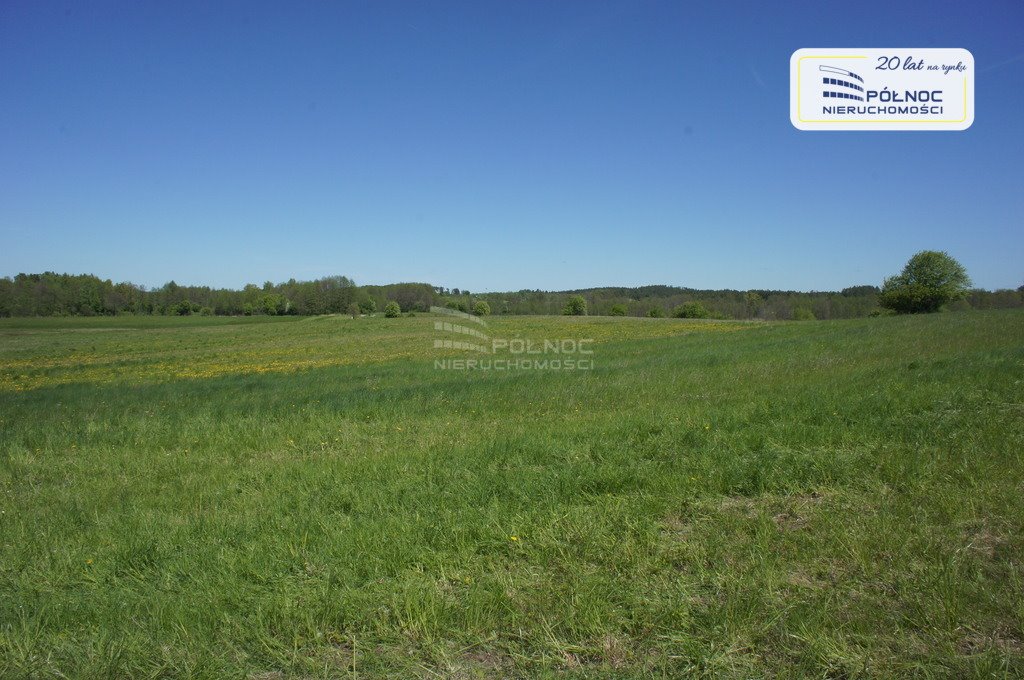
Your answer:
(0, 271), (1024, 320)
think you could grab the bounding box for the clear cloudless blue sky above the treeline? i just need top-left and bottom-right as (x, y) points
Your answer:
(0, 0), (1024, 291)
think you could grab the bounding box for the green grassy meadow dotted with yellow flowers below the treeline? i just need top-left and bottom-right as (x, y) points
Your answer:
(0, 311), (1024, 678)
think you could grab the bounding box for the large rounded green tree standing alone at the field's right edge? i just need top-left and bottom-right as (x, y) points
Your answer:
(879, 250), (971, 314)
